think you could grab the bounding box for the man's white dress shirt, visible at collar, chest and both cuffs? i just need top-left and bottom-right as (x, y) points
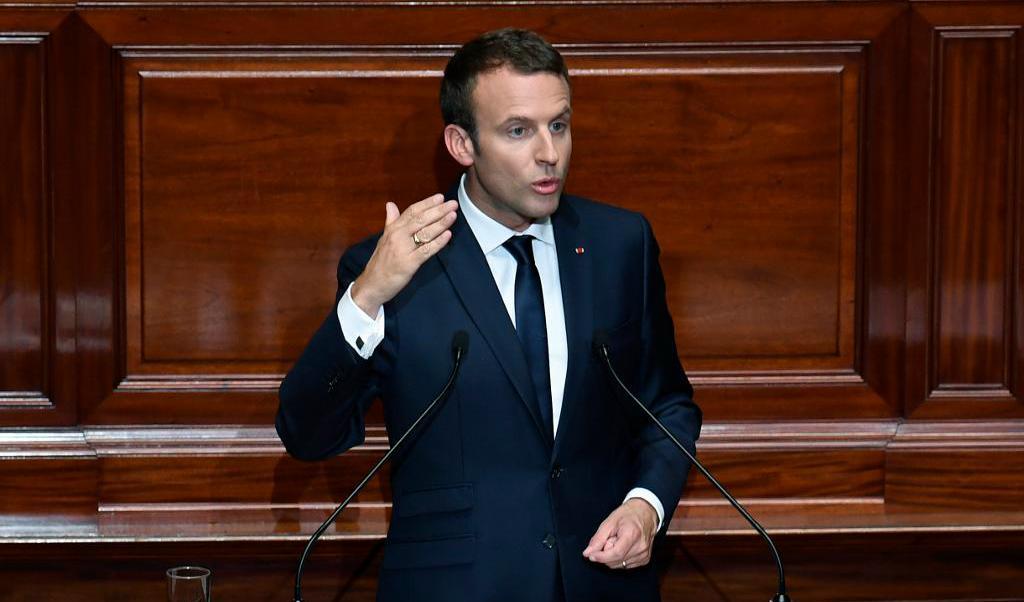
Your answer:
(338, 175), (665, 528)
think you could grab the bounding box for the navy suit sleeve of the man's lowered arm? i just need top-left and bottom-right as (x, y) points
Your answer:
(636, 213), (701, 532)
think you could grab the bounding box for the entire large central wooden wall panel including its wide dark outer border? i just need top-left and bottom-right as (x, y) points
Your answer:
(51, 3), (902, 424)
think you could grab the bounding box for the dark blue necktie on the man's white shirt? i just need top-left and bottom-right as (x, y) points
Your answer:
(503, 234), (555, 438)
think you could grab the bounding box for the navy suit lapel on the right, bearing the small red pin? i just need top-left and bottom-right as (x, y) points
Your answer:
(552, 198), (594, 458)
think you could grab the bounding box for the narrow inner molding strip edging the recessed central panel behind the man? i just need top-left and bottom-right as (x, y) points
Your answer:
(103, 47), (884, 423)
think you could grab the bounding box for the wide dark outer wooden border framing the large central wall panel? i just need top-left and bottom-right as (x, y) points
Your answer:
(66, 3), (906, 424)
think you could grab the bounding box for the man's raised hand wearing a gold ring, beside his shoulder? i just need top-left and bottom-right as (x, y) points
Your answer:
(352, 195), (459, 316)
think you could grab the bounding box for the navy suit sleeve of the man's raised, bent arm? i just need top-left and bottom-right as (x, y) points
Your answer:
(276, 240), (379, 461)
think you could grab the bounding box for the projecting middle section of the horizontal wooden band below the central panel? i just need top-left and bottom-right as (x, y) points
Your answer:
(85, 423), (895, 508)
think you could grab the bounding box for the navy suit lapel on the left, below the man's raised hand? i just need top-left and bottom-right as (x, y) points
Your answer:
(437, 206), (552, 445)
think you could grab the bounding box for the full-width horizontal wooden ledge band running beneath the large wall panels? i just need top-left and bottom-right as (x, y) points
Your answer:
(0, 420), (1024, 522)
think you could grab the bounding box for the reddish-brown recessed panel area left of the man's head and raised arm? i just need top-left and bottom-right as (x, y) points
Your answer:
(124, 52), (455, 370)
